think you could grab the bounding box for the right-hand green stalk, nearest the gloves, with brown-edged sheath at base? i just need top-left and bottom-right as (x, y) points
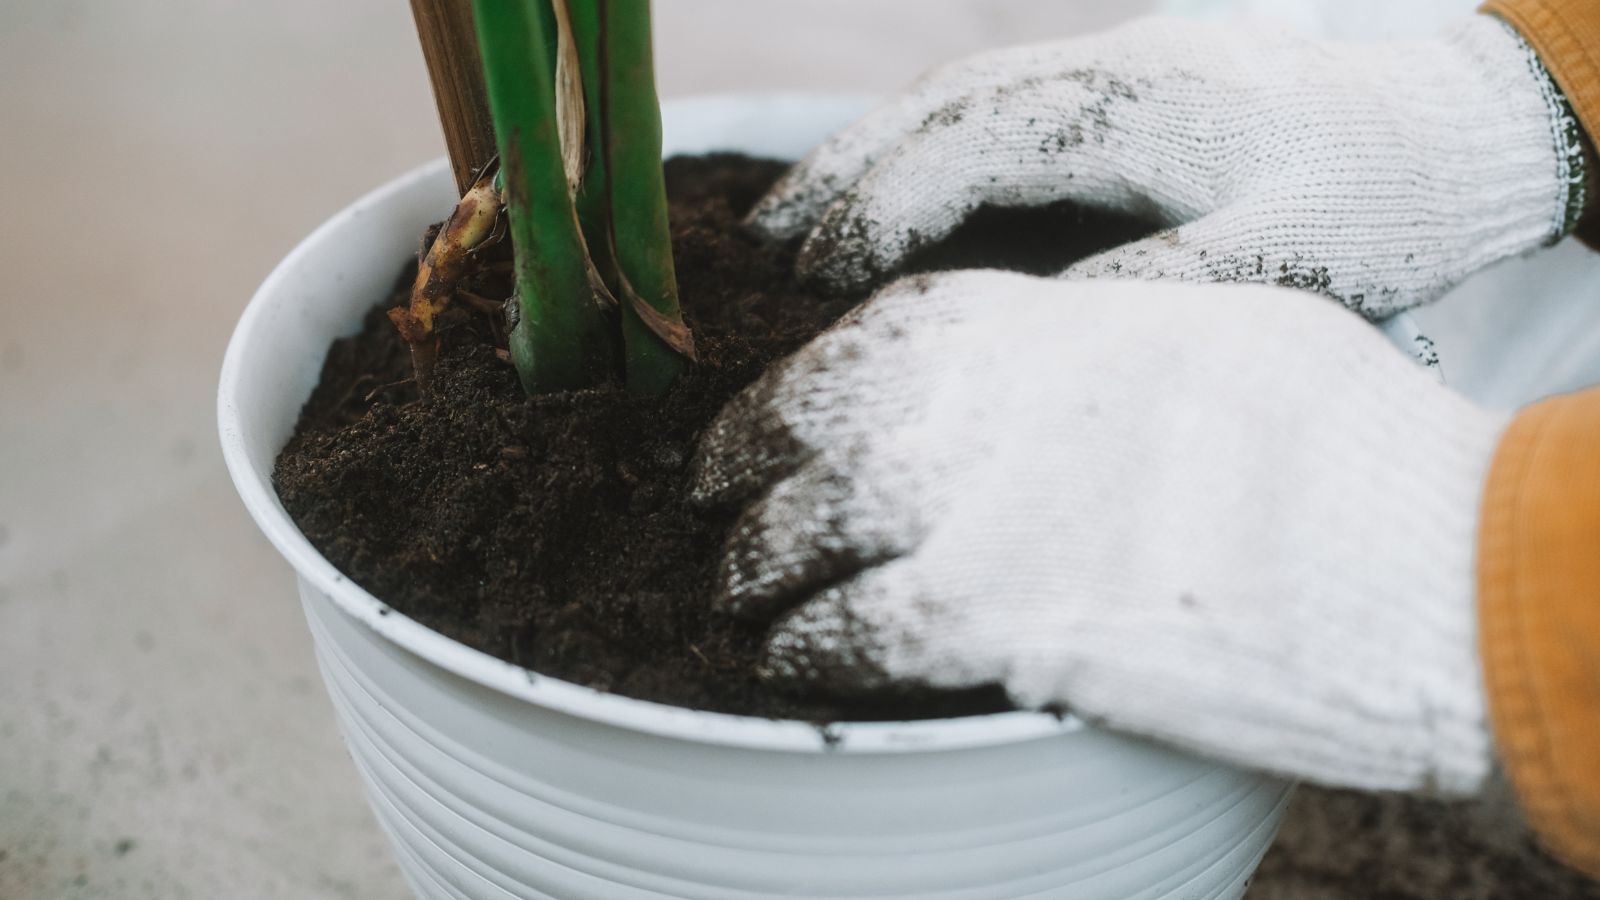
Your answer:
(598, 0), (694, 394)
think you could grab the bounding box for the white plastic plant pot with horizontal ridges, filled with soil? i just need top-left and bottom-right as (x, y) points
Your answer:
(219, 96), (1290, 900)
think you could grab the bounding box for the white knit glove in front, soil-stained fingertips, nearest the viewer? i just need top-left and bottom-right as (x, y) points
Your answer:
(694, 272), (1504, 793)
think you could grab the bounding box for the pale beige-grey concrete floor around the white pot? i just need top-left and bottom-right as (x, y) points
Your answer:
(0, 0), (1593, 900)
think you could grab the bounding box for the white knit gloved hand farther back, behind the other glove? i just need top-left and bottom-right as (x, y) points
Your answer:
(750, 16), (1584, 317)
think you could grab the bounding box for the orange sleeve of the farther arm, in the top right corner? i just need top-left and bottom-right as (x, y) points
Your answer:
(1478, 0), (1600, 250)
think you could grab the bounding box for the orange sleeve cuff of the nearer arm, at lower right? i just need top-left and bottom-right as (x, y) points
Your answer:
(1478, 381), (1600, 878)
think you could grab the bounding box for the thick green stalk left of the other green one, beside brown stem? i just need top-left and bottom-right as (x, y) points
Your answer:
(472, 0), (611, 394)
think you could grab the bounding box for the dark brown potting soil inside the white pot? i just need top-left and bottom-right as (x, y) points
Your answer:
(274, 155), (1150, 721)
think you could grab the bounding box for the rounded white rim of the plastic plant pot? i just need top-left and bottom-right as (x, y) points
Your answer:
(218, 93), (1085, 753)
